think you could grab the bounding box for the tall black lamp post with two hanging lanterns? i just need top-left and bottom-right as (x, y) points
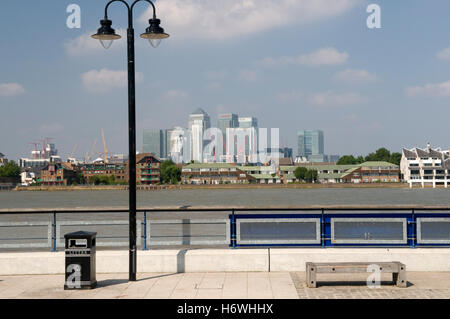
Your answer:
(92, 0), (169, 281)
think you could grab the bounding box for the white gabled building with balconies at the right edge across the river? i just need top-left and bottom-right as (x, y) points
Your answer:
(400, 143), (450, 188)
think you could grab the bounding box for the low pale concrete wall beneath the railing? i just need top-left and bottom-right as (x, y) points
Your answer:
(0, 248), (450, 275)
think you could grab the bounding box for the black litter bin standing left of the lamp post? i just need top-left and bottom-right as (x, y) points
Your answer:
(64, 231), (97, 290)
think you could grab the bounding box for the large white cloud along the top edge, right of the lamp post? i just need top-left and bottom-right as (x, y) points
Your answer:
(140, 0), (361, 39)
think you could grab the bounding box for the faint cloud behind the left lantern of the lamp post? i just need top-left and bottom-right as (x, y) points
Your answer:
(64, 29), (127, 56)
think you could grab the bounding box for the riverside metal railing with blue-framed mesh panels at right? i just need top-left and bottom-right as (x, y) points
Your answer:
(0, 207), (450, 252)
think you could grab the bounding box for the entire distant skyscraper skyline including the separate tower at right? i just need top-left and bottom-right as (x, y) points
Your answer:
(143, 108), (339, 164)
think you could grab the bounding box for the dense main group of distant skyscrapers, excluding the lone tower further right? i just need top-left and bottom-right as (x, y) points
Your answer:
(143, 108), (258, 163)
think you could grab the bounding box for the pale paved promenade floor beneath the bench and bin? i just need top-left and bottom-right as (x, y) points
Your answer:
(0, 272), (450, 299)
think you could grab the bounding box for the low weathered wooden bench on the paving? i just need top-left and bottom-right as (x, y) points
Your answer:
(306, 261), (406, 288)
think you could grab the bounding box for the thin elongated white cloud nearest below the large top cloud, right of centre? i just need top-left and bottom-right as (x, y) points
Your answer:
(255, 47), (349, 67)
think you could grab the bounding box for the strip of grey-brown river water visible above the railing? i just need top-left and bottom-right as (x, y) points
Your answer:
(0, 188), (450, 209)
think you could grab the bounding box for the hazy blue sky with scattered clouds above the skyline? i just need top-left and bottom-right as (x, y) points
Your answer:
(0, 0), (450, 160)
